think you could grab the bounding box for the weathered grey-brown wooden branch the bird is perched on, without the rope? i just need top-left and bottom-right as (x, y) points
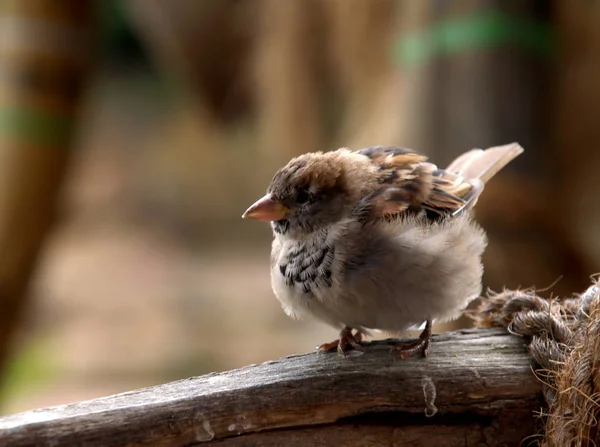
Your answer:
(0, 329), (542, 447)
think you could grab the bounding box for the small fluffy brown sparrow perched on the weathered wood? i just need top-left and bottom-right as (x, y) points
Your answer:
(242, 143), (523, 358)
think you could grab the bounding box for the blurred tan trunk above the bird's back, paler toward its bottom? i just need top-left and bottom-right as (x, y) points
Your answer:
(321, 0), (404, 148)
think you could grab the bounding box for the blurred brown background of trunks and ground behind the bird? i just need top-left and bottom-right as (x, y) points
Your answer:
(0, 0), (600, 414)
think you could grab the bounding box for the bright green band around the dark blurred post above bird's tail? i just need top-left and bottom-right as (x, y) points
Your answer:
(394, 11), (556, 66)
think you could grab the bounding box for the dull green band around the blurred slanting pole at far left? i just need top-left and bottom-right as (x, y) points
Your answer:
(0, 107), (73, 146)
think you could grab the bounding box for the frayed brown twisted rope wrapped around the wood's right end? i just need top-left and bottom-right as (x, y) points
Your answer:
(470, 281), (600, 447)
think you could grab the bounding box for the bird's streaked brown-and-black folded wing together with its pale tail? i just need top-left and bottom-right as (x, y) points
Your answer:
(358, 143), (523, 218)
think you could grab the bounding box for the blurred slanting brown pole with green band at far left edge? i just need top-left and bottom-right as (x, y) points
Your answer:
(0, 0), (91, 382)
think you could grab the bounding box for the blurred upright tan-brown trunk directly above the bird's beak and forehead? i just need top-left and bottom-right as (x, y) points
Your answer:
(255, 0), (326, 163)
